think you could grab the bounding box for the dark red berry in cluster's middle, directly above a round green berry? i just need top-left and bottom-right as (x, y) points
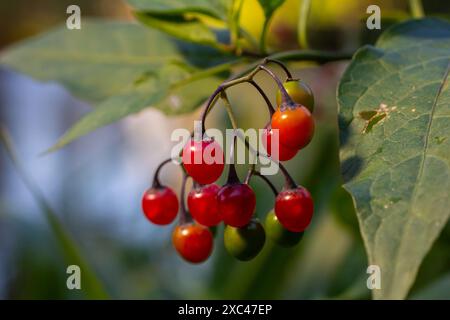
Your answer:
(217, 183), (256, 227)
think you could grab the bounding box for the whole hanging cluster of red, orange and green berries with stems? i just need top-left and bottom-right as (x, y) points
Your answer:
(142, 59), (314, 263)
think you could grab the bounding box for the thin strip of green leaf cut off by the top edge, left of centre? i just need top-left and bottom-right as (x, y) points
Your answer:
(128, 0), (228, 18)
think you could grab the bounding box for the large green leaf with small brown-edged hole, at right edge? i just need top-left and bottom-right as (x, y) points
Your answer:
(338, 19), (450, 299)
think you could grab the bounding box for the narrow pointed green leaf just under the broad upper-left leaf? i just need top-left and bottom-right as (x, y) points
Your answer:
(47, 64), (228, 152)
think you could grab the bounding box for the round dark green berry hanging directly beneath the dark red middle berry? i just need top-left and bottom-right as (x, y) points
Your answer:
(224, 219), (266, 261)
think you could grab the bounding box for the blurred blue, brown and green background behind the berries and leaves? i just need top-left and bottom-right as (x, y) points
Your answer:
(0, 0), (450, 299)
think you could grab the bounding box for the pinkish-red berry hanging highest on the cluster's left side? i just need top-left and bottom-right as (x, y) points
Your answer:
(182, 139), (224, 184)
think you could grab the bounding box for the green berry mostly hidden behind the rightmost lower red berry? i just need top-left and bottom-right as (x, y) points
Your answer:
(264, 210), (303, 248)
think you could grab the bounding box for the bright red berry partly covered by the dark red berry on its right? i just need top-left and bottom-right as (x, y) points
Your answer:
(187, 184), (222, 227)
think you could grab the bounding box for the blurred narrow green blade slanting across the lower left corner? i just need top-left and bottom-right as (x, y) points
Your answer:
(0, 127), (109, 299)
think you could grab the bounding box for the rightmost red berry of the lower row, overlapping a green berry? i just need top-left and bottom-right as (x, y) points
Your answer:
(275, 187), (314, 232)
